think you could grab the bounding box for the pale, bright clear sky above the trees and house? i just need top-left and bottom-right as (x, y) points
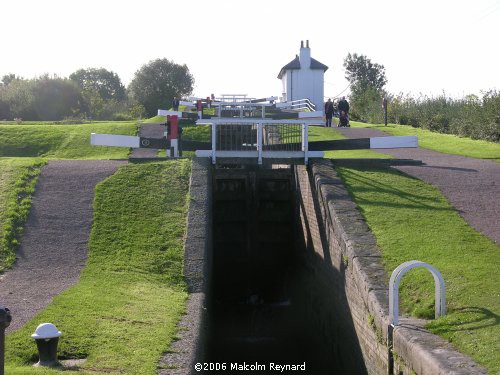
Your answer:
(0, 0), (500, 97)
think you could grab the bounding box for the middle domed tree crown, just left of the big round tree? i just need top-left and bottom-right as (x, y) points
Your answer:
(69, 68), (126, 102)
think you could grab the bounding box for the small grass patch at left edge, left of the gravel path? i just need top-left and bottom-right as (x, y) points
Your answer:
(0, 158), (45, 273)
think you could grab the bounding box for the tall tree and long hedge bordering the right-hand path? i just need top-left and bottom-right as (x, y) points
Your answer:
(344, 54), (500, 142)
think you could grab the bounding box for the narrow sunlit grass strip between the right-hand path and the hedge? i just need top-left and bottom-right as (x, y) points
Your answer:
(351, 121), (500, 163)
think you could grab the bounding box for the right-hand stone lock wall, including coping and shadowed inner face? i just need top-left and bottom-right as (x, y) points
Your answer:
(295, 160), (486, 375)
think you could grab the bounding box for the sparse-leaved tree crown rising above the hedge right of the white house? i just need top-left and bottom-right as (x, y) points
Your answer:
(344, 53), (387, 94)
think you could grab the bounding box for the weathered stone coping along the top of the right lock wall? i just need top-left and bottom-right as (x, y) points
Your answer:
(310, 160), (488, 375)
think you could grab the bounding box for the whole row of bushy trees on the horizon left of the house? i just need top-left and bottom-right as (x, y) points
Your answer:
(0, 59), (194, 121)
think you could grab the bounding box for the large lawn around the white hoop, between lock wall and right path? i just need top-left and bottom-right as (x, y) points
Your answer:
(338, 168), (500, 374)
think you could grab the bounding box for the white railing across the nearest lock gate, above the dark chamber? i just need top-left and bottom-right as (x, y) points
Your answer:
(196, 118), (324, 164)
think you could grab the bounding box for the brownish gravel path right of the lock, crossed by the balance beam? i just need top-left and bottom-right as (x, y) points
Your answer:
(335, 128), (500, 244)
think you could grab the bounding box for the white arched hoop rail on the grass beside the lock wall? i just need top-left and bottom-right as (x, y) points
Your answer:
(389, 260), (446, 326)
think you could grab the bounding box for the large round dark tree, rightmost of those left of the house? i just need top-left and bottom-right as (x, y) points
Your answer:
(129, 59), (194, 116)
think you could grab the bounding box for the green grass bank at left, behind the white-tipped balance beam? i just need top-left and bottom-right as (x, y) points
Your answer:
(0, 122), (137, 159)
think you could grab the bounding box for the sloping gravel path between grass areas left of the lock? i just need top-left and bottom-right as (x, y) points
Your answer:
(0, 160), (126, 332)
